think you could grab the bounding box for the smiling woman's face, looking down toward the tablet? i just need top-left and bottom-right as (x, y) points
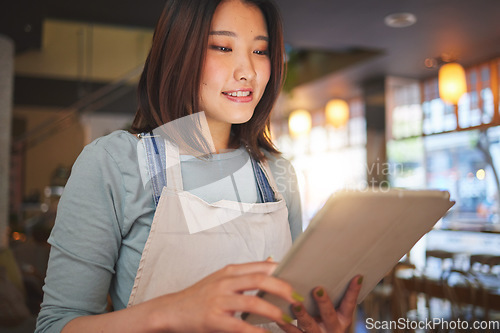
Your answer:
(200, 0), (271, 130)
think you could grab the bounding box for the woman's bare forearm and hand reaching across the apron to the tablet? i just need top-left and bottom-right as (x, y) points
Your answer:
(63, 262), (296, 333)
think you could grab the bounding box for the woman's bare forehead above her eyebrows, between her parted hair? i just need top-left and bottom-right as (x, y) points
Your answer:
(211, 0), (267, 35)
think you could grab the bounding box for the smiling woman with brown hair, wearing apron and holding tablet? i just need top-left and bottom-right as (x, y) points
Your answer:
(37, 0), (361, 332)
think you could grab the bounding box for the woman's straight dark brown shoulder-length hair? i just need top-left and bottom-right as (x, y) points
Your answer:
(131, 0), (284, 160)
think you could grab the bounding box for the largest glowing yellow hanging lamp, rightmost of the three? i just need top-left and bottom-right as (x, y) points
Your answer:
(438, 62), (467, 105)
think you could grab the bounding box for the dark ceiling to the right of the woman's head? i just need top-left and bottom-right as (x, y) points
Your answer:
(278, 0), (500, 97)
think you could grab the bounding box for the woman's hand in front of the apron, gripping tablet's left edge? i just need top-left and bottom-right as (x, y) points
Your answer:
(146, 261), (298, 333)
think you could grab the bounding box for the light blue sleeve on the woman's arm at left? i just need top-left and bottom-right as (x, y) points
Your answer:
(36, 141), (126, 332)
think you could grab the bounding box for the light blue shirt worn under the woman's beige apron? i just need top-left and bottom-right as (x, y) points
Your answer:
(36, 131), (302, 332)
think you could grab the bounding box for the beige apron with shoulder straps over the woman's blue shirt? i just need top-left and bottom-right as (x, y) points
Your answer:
(128, 142), (292, 330)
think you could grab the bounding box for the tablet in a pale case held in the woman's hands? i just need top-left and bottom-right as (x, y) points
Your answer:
(243, 189), (455, 324)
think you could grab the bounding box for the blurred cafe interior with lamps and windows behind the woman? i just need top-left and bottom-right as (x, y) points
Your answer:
(0, 0), (500, 332)
